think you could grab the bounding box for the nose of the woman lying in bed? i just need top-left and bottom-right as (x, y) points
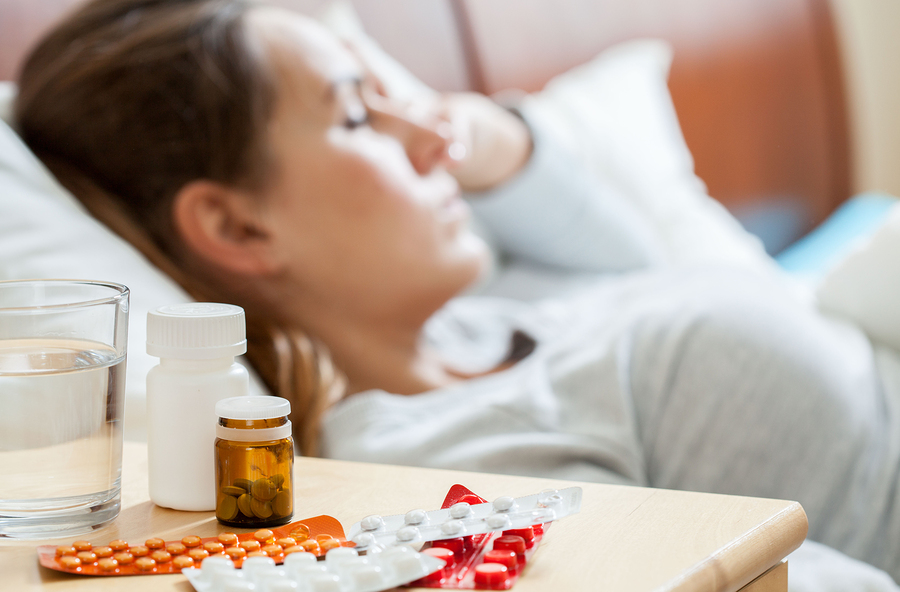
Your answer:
(370, 102), (453, 175)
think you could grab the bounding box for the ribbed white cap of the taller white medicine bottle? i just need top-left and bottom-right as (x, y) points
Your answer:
(147, 302), (247, 360)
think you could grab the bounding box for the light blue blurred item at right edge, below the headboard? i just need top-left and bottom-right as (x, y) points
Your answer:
(775, 193), (898, 279)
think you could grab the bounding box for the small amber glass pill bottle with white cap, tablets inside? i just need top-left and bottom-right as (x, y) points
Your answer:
(215, 396), (294, 528)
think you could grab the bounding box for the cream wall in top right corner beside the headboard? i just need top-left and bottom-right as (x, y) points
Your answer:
(831, 0), (900, 196)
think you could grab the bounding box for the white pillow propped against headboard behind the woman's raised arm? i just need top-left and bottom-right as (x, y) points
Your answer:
(521, 39), (776, 272)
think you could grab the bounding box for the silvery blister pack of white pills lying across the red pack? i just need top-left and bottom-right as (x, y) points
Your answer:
(347, 487), (582, 553)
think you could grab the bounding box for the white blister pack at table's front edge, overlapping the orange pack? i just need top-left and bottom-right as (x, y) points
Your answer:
(181, 546), (444, 592)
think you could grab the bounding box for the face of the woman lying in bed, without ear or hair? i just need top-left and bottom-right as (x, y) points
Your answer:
(250, 9), (487, 322)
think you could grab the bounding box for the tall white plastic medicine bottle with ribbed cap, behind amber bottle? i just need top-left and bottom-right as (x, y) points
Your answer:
(147, 302), (250, 511)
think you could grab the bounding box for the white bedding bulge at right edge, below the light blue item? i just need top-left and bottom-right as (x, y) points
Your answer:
(817, 204), (900, 351)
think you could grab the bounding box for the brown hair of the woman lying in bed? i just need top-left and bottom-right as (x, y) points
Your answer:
(15, 0), (343, 454)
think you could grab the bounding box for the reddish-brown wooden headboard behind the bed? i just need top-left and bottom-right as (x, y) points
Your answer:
(0, 0), (852, 236)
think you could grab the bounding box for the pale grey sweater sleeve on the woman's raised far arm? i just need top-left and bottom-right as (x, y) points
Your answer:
(466, 109), (664, 272)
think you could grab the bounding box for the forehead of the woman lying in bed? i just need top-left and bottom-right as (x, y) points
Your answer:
(249, 7), (361, 99)
